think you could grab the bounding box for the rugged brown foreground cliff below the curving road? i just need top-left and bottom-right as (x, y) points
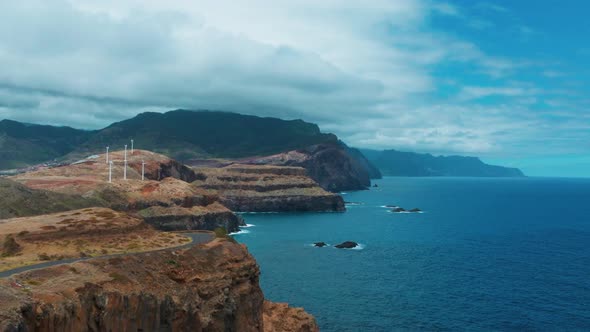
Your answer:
(0, 239), (317, 332)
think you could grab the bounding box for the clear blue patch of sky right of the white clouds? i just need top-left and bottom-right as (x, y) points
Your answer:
(433, 0), (590, 177)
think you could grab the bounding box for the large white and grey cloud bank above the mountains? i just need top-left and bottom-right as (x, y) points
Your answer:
(0, 0), (588, 158)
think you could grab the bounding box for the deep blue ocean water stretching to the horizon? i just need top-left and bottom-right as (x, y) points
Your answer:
(235, 178), (590, 331)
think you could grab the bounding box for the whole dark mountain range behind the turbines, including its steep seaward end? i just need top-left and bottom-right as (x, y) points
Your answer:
(0, 110), (375, 191)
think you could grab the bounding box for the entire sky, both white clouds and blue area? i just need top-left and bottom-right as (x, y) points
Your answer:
(0, 0), (590, 177)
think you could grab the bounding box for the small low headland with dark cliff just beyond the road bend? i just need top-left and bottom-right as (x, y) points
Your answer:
(139, 202), (246, 233)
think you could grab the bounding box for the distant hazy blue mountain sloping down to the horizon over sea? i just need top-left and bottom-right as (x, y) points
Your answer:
(361, 149), (524, 177)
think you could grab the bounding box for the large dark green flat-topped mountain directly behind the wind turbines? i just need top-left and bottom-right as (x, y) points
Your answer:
(75, 110), (337, 161)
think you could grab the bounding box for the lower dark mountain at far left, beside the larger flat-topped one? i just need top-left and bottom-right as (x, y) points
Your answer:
(0, 120), (94, 169)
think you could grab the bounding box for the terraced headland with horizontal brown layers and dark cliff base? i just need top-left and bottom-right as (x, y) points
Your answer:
(193, 164), (345, 212)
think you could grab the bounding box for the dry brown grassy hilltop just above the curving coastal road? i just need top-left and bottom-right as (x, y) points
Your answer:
(0, 208), (190, 276)
